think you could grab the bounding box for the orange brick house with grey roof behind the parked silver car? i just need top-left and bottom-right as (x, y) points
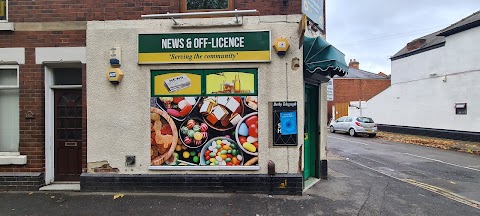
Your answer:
(327, 59), (390, 120)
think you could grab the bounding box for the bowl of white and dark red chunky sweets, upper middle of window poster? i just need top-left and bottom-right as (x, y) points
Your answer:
(200, 96), (244, 131)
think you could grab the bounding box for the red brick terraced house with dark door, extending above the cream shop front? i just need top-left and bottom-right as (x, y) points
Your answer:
(0, 0), (301, 190)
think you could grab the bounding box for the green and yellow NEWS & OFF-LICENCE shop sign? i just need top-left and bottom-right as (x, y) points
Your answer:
(138, 31), (271, 64)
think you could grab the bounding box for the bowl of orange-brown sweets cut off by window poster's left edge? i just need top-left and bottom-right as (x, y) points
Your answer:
(150, 107), (178, 165)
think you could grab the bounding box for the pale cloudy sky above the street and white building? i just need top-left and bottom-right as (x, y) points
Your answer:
(325, 0), (480, 74)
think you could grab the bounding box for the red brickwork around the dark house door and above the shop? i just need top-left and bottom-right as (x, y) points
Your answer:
(0, 0), (301, 184)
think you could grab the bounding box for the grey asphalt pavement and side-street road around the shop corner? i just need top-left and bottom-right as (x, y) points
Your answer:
(0, 134), (480, 216)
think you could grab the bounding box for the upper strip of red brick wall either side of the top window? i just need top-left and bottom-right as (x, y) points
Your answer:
(8, 0), (301, 22)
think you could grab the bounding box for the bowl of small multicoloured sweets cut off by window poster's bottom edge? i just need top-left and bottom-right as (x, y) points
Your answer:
(200, 137), (244, 166)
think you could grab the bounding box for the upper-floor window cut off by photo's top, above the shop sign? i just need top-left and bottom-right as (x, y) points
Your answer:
(180, 0), (233, 12)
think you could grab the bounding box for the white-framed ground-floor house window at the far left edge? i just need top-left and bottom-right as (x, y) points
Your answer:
(0, 65), (20, 152)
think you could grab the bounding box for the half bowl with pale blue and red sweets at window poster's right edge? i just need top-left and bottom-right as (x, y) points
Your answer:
(235, 112), (258, 156)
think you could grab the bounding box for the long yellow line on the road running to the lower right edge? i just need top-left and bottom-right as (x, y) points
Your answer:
(347, 159), (480, 209)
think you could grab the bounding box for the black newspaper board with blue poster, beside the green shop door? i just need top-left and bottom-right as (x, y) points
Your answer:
(272, 101), (298, 146)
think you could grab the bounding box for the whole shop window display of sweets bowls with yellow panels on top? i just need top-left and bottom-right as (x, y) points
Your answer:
(150, 69), (261, 169)
